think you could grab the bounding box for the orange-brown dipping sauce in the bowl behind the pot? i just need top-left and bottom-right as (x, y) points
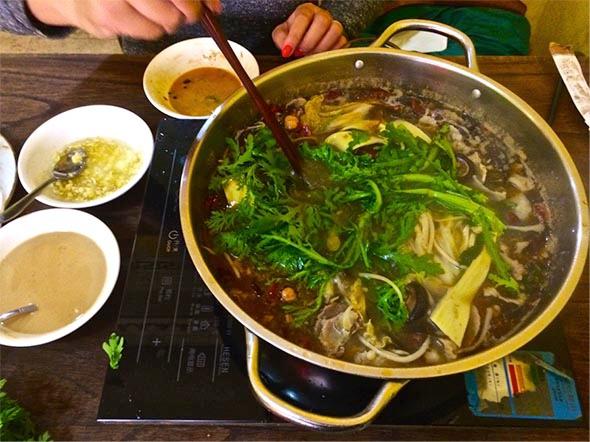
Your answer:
(168, 68), (240, 115)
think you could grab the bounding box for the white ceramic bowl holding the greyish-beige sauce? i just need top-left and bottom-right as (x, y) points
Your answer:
(0, 209), (121, 347)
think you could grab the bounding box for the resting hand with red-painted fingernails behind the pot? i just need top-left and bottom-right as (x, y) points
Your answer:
(272, 3), (348, 58)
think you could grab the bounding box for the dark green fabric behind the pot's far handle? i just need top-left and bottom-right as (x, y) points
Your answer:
(365, 5), (531, 55)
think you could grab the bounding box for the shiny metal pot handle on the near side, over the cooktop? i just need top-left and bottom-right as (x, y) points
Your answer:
(245, 329), (409, 431)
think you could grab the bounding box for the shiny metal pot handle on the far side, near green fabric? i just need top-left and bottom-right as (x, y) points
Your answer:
(371, 19), (479, 72)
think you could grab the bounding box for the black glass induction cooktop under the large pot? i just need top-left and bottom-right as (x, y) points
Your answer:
(98, 119), (585, 426)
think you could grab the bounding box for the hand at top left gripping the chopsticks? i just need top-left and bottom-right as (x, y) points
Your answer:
(26, 0), (222, 40)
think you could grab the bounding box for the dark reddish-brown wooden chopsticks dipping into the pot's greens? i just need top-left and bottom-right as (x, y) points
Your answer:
(201, 6), (301, 174)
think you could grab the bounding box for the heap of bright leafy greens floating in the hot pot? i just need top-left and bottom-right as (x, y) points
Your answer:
(207, 123), (518, 326)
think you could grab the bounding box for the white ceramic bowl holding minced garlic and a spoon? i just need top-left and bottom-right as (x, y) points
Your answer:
(18, 104), (154, 209)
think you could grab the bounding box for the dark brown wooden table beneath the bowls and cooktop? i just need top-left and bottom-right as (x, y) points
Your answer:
(0, 55), (588, 440)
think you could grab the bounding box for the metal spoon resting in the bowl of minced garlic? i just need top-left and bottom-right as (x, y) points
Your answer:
(0, 147), (86, 224)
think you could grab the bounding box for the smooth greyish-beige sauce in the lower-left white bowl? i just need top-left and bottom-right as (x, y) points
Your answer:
(0, 232), (106, 334)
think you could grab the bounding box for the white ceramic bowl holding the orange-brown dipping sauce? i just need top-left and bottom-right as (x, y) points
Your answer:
(143, 37), (260, 120)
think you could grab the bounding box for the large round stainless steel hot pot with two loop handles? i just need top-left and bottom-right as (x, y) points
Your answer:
(180, 20), (588, 429)
